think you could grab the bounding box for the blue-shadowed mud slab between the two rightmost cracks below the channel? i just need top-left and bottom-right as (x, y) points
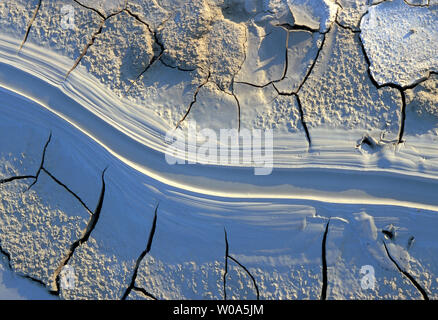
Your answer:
(327, 212), (421, 300)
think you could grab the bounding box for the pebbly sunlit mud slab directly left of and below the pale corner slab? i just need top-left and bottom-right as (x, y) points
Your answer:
(299, 25), (401, 136)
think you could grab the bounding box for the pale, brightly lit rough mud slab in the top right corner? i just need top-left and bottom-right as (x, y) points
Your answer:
(360, 0), (438, 87)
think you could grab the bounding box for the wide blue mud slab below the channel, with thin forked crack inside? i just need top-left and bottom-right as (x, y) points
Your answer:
(136, 203), (325, 299)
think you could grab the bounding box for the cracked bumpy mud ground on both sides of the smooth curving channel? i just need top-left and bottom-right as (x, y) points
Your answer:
(0, 0), (438, 300)
